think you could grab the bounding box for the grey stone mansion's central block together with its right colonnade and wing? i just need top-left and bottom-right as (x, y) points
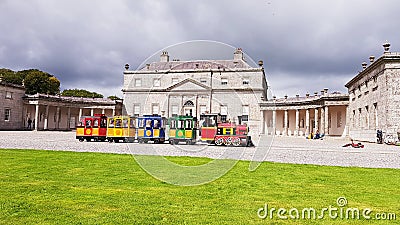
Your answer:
(122, 43), (400, 142)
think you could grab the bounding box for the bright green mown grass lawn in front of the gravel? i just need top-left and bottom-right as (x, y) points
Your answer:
(0, 149), (400, 224)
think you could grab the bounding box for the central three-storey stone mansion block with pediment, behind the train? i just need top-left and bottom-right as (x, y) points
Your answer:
(122, 49), (267, 135)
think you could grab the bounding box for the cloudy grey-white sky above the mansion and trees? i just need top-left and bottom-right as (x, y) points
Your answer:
(0, 0), (400, 97)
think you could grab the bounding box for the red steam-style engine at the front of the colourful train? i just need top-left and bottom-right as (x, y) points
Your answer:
(200, 114), (253, 146)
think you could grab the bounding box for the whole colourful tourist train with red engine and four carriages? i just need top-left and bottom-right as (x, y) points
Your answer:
(76, 114), (253, 146)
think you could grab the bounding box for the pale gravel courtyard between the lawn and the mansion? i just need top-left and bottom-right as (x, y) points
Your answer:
(0, 131), (400, 168)
